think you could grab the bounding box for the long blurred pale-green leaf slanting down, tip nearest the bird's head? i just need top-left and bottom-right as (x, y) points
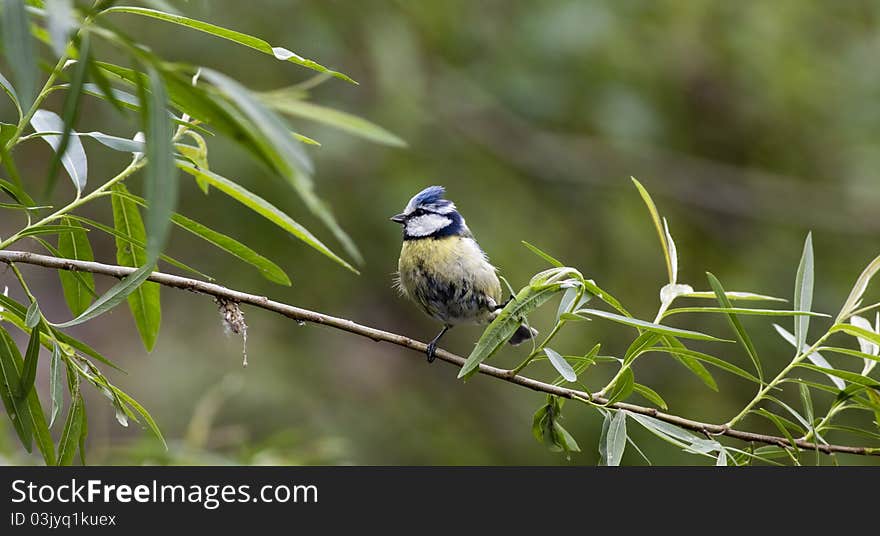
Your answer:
(202, 69), (363, 263)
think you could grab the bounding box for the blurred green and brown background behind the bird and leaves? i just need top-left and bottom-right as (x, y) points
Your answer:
(0, 0), (880, 465)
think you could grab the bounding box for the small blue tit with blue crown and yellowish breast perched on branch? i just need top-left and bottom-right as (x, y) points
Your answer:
(391, 186), (538, 362)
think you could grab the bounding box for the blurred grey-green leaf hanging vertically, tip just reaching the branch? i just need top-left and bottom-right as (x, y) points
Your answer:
(139, 66), (177, 262)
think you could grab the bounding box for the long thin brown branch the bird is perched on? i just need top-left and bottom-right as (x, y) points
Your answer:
(0, 251), (880, 456)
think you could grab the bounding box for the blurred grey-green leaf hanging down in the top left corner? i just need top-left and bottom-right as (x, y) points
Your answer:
(2, 0), (37, 110)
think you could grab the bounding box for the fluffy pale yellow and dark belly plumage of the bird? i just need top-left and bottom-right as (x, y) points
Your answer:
(398, 236), (501, 324)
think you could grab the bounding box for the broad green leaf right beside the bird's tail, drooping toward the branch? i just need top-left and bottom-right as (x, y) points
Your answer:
(458, 283), (560, 379)
